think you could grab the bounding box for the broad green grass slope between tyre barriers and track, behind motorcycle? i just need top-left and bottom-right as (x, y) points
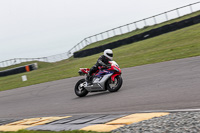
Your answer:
(0, 24), (200, 91)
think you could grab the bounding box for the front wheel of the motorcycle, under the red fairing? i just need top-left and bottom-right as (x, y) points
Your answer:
(106, 75), (123, 92)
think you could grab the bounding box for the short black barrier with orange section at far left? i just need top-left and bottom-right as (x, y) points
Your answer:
(0, 63), (38, 77)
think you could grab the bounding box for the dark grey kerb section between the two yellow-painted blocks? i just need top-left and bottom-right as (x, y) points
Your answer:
(28, 114), (127, 131)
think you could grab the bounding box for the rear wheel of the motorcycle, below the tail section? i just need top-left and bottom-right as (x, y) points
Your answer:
(74, 79), (88, 97)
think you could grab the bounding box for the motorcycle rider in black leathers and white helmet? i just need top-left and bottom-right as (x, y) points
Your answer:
(86, 49), (113, 85)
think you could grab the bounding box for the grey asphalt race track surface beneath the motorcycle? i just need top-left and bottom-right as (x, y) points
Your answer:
(0, 56), (200, 118)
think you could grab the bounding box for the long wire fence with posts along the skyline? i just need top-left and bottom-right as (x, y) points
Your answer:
(0, 1), (200, 67)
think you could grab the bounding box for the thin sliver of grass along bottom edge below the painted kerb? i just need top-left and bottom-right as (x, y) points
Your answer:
(0, 130), (109, 133)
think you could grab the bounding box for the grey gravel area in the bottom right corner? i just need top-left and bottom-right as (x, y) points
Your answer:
(112, 112), (200, 133)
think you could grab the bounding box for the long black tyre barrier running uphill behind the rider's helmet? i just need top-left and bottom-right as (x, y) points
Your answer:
(74, 15), (200, 58)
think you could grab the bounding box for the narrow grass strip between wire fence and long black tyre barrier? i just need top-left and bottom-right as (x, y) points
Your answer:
(80, 11), (200, 51)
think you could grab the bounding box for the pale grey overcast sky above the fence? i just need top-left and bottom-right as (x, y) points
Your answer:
(0, 0), (199, 61)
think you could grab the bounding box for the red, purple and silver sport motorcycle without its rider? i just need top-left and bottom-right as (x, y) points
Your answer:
(74, 61), (123, 97)
